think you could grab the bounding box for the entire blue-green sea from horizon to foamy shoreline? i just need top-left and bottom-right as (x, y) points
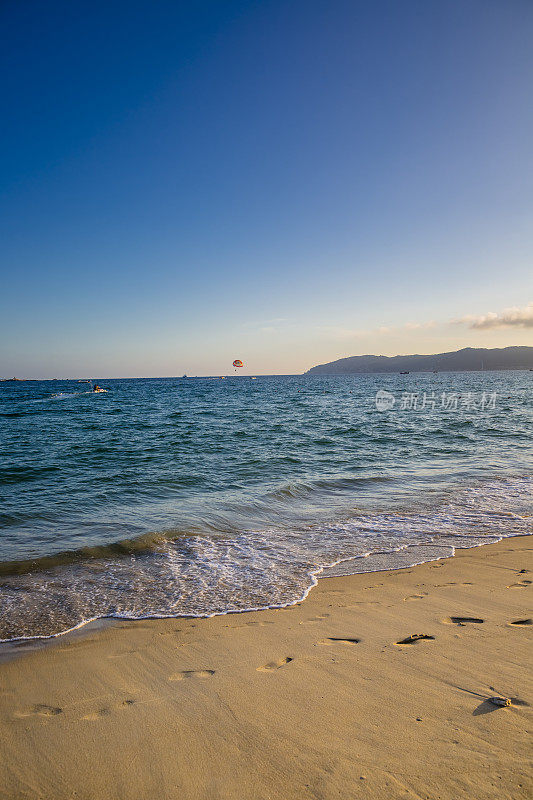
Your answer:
(0, 371), (533, 640)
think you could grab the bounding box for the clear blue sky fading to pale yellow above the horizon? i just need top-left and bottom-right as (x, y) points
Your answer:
(0, 0), (533, 377)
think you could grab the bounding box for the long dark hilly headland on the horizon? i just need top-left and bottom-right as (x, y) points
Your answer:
(305, 347), (533, 375)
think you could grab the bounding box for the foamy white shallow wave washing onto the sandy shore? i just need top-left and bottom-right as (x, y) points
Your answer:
(0, 477), (533, 641)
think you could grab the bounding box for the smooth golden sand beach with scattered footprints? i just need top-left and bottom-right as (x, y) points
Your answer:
(0, 537), (533, 800)
